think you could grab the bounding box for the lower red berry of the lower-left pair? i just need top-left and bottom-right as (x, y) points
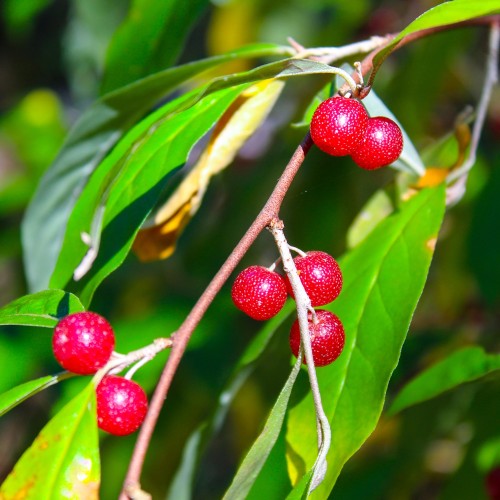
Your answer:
(96, 375), (148, 436)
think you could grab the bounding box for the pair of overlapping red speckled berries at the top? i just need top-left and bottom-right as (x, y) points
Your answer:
(311, 97), (403, 170)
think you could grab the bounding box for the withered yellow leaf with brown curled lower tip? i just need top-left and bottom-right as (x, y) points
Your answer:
(132, 80), (284, 262)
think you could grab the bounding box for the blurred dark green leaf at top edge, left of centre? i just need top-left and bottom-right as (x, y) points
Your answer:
(102, 0), (209, 94)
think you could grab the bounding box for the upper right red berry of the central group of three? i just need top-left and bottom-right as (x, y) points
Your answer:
(287, 251), (342, 307)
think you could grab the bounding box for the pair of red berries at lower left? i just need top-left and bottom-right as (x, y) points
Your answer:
(52, 311), (148, 436)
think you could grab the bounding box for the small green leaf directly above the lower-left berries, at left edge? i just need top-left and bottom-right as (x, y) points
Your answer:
(0, 290), (85, 328)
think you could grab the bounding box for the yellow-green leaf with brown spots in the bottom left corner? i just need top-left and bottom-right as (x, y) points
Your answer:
(0, 384), (100, 500)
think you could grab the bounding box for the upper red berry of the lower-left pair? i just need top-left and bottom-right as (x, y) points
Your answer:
(52, 311), (115, 375)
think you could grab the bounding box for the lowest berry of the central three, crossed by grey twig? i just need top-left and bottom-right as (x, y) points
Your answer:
(290, 309), (345, 366)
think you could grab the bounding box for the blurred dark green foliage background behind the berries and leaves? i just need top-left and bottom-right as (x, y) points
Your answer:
(0, 0), (500, 500)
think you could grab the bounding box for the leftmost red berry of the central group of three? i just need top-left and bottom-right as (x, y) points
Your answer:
(231, 266), (288, 320)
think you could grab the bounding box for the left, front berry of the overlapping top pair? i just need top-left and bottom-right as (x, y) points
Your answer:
(311, 97), (369, 156)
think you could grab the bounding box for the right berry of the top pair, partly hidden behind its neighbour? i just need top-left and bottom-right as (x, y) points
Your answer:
(352, 116), (403, 170)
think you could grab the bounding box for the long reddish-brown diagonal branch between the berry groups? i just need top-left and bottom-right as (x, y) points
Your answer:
(120, 133), (312, 500)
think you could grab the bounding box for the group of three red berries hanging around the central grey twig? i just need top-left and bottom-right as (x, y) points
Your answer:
(231, 251), (345, 366)
